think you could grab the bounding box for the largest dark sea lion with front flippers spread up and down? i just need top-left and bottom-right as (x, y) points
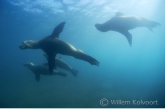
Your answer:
(19, 22), (99, 74)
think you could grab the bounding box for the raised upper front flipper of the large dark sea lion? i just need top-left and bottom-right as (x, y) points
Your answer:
(49, 22), (66, 38)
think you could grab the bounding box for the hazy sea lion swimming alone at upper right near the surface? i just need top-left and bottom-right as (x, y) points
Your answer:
(95, 12), (160, 46)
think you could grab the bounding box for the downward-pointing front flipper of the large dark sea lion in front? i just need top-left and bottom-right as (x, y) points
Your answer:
(48, 54), (56, 75)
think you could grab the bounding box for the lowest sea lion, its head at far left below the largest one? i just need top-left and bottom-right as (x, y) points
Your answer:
(24, 63), (67, 82)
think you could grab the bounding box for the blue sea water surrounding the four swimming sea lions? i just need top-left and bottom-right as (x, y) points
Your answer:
(0, 0), (165, 108)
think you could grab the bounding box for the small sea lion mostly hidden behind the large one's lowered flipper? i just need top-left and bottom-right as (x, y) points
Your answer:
(44, 54), (78, 77)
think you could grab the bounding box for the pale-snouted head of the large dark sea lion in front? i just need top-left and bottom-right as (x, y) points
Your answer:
(19, 40), (36, 50)
